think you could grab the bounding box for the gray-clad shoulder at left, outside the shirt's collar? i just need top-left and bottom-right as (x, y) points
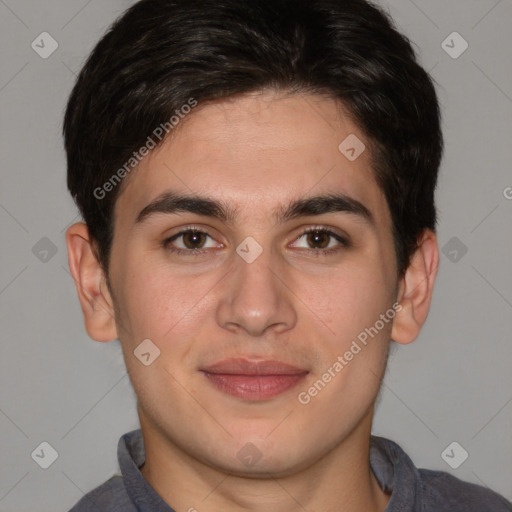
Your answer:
(69, 475), (136, 512)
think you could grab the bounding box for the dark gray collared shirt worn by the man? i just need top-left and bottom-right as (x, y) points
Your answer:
(70, 429), (512, 512)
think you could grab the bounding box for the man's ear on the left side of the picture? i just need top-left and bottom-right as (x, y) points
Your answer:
(66, 222), (117, 341)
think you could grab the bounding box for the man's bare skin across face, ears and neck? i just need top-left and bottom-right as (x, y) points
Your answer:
(66, 91), (439, 512)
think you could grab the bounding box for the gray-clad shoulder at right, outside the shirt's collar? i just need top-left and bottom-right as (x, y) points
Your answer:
(418, 469), (512, 512)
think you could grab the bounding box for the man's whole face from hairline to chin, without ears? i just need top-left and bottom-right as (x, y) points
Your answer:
(110, 92), (397, 475)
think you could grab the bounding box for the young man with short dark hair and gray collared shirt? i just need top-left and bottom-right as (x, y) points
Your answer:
(64, 0), (512, 512)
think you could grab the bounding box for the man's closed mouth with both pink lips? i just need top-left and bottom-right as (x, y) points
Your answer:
(200, 358), (309, 401)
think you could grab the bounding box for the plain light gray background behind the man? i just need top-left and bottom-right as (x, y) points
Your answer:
(0, 0), (512, 512)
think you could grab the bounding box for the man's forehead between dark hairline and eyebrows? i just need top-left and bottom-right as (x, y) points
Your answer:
(116, 92), (388, 229)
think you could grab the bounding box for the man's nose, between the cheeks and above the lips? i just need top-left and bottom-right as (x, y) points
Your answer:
(217, 243), (297, 336)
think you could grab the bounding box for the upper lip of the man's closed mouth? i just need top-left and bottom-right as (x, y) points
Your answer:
(201, 358), (308, 375)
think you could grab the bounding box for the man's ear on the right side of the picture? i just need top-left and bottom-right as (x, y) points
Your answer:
(391, 229), (439, 345)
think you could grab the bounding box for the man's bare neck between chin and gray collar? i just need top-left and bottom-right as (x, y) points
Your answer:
(139, 407), (390, 512)
